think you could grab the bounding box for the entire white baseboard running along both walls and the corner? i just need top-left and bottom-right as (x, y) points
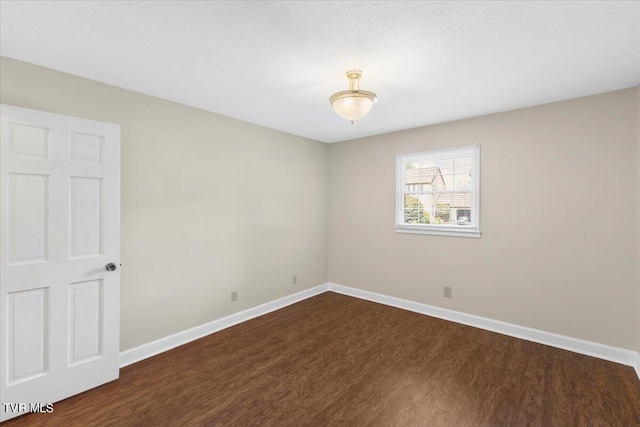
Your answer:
(120, 282), (640, 380)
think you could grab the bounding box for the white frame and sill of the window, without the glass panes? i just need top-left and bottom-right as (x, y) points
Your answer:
(395, 145), (482, 238)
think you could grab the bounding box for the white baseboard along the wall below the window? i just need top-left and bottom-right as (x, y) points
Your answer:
(328, 283), (640, 379)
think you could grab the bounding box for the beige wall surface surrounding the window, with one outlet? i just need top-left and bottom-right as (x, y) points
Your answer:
(328, 89), (638, 349)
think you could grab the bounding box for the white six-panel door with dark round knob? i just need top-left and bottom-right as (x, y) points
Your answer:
(0, 105), (120, 420)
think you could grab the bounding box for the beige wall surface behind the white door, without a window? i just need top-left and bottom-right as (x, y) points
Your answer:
(0, 58), (327, 350)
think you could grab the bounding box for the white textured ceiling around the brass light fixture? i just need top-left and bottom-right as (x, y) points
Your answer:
(0, 0), (640, 142)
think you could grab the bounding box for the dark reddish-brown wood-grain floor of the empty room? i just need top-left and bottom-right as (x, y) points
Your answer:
(3, 293), (640, 427)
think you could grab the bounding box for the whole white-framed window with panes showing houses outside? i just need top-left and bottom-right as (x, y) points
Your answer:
(396, 145), (480, 237)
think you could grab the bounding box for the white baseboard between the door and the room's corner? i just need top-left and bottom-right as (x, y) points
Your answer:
(120, 284), (328, 368)
